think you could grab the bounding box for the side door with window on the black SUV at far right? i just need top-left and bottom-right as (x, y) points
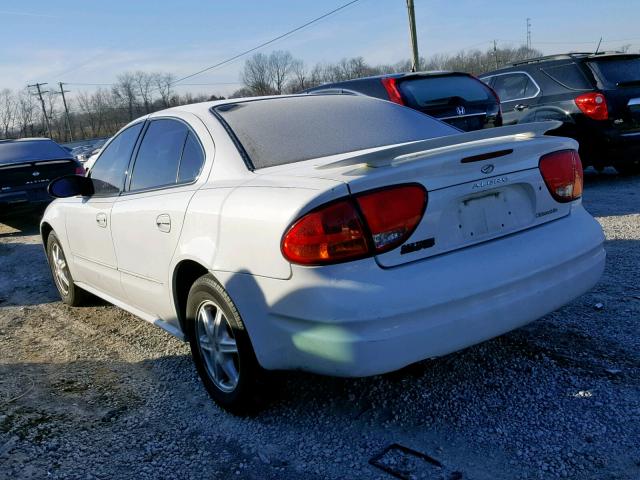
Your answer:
(485, 72), (540, 125)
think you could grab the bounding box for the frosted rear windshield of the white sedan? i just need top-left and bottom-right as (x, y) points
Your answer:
(212, 95), (459, 168)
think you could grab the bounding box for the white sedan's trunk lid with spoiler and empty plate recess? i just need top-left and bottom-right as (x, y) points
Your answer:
(262, 122), (577, 267)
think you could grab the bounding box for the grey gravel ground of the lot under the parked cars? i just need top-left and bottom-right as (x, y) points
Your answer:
(0, 171), (640, 480)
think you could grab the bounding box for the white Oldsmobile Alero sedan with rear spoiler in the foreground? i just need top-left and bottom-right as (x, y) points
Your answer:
(41, 95), (605, 410)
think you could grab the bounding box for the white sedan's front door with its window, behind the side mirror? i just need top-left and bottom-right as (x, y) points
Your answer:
(65, 122), (144, 298)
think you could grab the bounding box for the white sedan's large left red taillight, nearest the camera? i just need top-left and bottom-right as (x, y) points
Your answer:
(282, 185), (427, 265)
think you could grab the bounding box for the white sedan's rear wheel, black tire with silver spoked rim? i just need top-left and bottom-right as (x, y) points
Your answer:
(186, 274), (264, 415)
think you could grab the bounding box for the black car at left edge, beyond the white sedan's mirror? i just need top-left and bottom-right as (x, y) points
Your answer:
(0, 138), (84, 212)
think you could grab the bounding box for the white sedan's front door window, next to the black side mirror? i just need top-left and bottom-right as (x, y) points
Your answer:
(89, 122), (144, 195)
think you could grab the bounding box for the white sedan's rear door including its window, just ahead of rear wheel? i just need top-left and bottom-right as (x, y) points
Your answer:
(111, 114), (205, 321)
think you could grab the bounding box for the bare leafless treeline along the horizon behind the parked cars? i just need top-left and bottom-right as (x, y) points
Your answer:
(0, 47), (542, 142)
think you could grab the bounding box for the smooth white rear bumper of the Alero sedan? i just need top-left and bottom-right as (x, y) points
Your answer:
(214, 205), (605, 376)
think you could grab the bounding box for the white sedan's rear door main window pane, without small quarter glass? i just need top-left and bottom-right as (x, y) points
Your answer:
(129, 118), (189, 191)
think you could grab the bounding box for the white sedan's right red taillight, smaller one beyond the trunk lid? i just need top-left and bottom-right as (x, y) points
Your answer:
(539, 150), (582, 203)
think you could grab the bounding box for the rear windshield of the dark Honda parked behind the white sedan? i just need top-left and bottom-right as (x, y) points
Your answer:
(399, 75), (495, 108)
